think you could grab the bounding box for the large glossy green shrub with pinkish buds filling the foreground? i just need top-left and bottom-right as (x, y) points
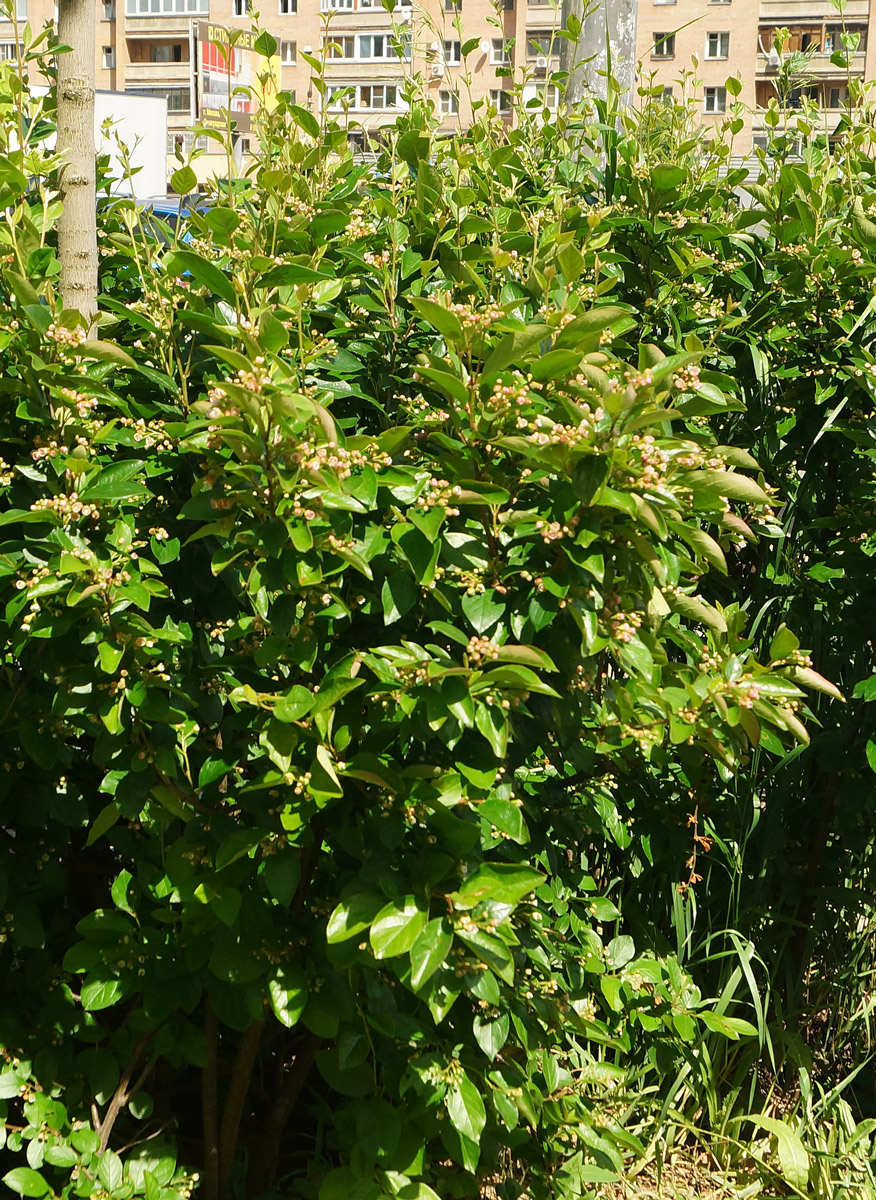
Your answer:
(0, 32), (863, 1200)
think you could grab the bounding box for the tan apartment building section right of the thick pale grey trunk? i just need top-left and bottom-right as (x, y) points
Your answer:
(636, 0), (876, 148)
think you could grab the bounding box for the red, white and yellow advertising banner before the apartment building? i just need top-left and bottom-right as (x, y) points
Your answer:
(198, 20), (280, 133)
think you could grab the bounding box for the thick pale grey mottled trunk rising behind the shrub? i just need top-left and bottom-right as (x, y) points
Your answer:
(560, 0), (637, 107)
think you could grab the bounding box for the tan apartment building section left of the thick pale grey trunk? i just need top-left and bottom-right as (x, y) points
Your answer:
(0, 0), (559, 186)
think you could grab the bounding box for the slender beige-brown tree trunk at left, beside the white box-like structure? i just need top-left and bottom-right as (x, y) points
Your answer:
(58, 0), (97, 329)
